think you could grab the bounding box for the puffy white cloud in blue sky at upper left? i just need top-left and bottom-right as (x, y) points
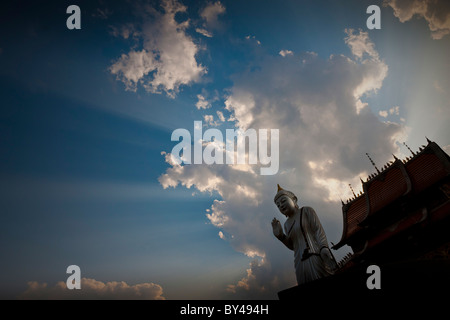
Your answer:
(109, 0), (206, 97)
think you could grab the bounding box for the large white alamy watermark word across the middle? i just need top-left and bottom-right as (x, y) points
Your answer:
(171, 121), (279, 175)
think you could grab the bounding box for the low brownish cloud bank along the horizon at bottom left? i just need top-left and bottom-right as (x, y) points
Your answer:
(20, 278), (165, 300)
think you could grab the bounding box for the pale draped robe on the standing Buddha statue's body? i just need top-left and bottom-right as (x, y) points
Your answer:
(284, 207), (336, 285)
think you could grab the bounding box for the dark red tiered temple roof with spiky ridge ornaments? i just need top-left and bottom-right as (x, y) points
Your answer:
(333, 139), (450, 249)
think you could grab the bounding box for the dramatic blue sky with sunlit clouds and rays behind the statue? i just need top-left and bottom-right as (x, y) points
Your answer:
(0, 0), (450, 299)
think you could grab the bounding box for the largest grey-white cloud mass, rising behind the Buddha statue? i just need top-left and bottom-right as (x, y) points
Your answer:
(159, 30), (404, 298)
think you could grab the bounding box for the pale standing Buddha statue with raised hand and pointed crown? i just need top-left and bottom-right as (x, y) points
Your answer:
(272, 185), (337, 285)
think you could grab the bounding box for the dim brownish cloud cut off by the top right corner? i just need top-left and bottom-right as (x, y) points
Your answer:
(385, 0), (450, 39)
